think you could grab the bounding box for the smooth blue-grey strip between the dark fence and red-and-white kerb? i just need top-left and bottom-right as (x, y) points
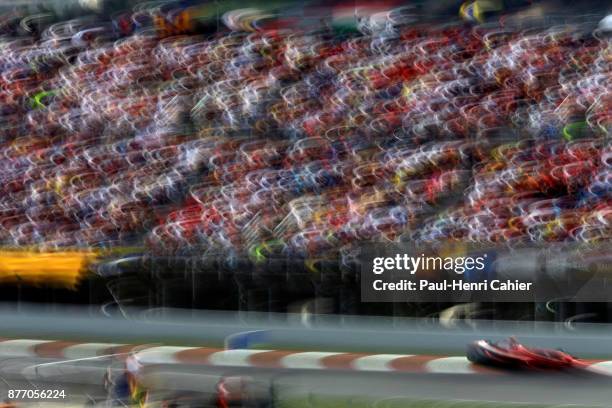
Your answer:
(0, 307), (612, 359)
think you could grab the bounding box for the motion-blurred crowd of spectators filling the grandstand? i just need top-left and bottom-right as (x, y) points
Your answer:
(0, 0), (612, 261)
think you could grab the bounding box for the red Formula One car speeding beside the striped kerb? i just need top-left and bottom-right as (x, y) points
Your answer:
(467, 337), (583, 370)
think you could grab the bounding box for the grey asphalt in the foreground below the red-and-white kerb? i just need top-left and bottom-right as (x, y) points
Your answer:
(0, 356), (612, 407)
